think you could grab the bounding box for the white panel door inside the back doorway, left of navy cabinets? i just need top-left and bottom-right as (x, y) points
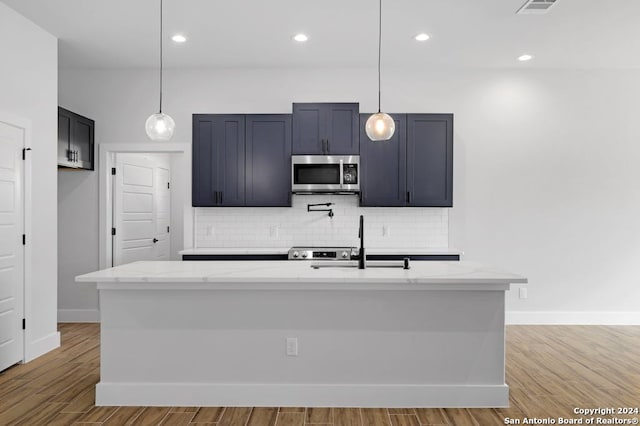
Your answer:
(113, 154), (170, 266)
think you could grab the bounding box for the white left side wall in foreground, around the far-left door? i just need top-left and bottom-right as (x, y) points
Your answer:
(0, 3), (60, 358)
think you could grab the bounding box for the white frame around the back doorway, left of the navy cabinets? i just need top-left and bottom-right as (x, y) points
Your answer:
(98, 142), (193, 269)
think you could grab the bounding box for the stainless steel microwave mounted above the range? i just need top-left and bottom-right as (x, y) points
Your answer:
(291, 155), (360, 193)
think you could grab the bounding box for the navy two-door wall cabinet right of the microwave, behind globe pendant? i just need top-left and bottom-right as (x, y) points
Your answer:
(360, 114), (453, 207)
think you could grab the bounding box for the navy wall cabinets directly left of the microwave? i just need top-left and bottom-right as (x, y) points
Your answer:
(192, 114), (291, 207)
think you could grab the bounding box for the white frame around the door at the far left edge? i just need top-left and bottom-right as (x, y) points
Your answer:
(0, 110), (31, 362)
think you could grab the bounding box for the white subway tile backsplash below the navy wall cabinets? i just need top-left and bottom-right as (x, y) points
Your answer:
(195, 195), (449, 248)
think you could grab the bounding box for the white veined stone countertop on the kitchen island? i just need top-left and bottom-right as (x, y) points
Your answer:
(76, 261), (527, 290)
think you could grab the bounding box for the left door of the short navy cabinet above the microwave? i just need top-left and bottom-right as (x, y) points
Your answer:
(292, 103), (326, 155)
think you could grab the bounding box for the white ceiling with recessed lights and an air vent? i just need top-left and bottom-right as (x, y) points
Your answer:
(3, 0), (640, 69)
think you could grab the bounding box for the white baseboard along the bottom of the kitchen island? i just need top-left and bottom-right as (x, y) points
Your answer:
(96, 382), (509, 408)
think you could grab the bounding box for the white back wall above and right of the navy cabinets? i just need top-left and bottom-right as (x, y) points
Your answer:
(60, 69), (640, 323)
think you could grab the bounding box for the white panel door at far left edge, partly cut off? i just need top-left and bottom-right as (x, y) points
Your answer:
(0, 121), (24, 371)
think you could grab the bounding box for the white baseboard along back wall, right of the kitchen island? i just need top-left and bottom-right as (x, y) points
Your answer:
(505, 311), (640, 325)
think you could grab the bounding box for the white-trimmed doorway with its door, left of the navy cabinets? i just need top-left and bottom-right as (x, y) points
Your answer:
(98, 143), (193, 269)
